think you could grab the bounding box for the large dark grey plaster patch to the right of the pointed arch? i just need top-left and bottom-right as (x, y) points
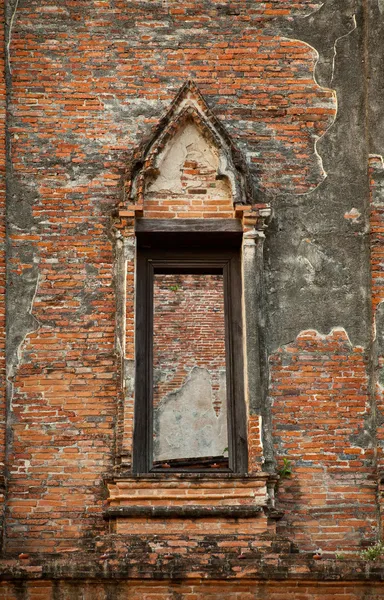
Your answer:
(265, 0), (370, 352)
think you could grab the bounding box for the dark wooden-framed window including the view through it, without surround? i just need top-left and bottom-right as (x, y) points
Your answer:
(133, 236), (247, 473)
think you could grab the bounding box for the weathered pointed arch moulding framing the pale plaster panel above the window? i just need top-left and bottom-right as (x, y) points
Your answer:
(120, 81), (255, 215)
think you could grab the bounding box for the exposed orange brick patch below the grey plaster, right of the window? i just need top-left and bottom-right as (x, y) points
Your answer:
(270, 329), (377, 552)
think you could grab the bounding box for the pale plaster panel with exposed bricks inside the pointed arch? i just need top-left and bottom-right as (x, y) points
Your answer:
(147, 123), (231, 199)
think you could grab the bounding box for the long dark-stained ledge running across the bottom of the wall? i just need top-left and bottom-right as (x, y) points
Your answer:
(0, 549), (384, 584)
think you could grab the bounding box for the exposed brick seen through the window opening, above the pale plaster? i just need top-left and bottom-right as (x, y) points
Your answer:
(153, 275), (226, 412)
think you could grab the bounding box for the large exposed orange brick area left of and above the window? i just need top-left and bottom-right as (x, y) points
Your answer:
(0, 0), (364, 551)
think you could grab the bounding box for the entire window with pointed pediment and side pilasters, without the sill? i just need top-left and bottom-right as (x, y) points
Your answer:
(114, 82), (274, 478)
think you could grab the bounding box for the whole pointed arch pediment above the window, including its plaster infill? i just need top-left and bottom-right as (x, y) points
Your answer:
(125, 81), (254, 216)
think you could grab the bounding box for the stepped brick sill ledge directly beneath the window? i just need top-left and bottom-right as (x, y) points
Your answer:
(104, 473), (274, 535)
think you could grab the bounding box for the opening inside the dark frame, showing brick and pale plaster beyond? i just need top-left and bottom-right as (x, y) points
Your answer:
(153, 273), (229, 468)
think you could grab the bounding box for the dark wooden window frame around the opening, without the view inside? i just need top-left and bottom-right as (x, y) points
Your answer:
(133, 244), (248, 475)
